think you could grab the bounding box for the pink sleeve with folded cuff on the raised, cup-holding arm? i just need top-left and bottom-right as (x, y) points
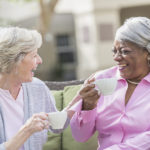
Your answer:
(70, 100), (96, 142)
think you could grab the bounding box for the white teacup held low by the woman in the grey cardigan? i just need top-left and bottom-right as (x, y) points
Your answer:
(48, 111), (67, 129)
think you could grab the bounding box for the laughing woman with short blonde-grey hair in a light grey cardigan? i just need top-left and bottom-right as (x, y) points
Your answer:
(0, 27), (69, 150)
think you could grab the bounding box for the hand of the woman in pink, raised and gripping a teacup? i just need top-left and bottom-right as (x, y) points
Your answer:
(79, 78), (100, 110)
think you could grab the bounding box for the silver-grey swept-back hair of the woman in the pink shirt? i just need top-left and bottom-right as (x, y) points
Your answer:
(115, 17), (150, 53)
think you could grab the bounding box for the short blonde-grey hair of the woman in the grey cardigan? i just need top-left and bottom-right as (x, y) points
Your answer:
(0, 27), (42, 73)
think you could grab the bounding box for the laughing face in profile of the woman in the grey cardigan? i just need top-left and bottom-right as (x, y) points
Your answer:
(14, 49), (42, 83)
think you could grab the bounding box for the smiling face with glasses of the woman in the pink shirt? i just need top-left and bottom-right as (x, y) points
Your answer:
(113, 41), (149, 81)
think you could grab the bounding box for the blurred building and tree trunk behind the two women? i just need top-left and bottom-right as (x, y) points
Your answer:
(0, 0), (150, 81)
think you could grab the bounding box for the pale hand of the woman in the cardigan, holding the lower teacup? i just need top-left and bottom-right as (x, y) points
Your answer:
(24, 112), (49, 134)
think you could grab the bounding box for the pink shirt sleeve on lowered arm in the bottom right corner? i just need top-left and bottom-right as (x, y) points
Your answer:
(104, 131), (150, 150)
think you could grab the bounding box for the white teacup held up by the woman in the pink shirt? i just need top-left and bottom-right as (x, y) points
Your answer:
(94, 78), (117, 96)
